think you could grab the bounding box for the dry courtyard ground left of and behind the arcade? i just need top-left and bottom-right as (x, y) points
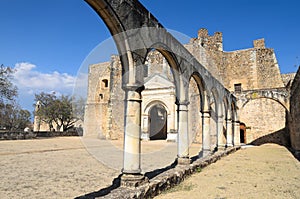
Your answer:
(0, 137), (201, 199)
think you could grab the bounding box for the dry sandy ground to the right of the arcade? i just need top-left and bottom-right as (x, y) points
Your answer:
(156, 144), (300, 199)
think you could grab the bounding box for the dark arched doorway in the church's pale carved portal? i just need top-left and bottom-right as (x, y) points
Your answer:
(149, 104), (168, 140)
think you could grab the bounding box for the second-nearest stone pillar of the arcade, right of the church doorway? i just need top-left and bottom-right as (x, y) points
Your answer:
(177, 102), (190, 164)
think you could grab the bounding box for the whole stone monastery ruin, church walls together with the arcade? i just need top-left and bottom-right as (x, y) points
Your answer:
(85, 0), (299, 186)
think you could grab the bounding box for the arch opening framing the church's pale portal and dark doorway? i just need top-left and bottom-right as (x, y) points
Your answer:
(141, 49), (177, 141)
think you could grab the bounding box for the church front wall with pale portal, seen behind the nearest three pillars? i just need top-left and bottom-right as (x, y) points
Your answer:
(84, 51), (202, 143)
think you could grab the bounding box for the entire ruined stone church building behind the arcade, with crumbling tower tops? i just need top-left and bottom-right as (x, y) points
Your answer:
(84, 29), (300, 150)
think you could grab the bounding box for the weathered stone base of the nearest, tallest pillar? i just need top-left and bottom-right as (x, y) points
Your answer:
(121, 174), (149, 188)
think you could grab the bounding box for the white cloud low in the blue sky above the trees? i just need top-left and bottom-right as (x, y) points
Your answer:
(13, 62), (87, 110)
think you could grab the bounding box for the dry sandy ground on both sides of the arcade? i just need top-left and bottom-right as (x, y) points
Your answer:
(0, 137), (300, 199)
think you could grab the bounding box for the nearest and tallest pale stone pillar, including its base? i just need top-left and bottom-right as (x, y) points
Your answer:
(121, 88), (145, 187)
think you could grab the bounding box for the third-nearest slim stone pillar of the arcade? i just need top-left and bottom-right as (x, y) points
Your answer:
(199, 111), (210, 157)
